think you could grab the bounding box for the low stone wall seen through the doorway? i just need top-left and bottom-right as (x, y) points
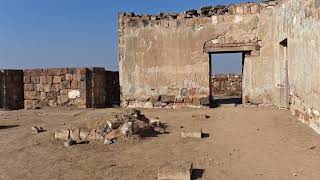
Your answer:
(211, 74), (242, 97)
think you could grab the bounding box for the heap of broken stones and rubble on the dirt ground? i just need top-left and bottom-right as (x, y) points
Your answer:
(54, 109), (165, 146)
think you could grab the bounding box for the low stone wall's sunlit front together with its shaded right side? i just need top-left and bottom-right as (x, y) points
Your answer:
(24, 67), (119, 109)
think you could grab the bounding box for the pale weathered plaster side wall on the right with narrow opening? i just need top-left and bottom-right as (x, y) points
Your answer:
(275, 0), (320, 133)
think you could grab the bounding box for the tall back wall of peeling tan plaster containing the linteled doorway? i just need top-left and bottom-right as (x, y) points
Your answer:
(119, 1), (277, 108)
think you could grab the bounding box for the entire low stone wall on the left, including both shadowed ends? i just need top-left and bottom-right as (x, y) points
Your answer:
(0, 67), (120, 109)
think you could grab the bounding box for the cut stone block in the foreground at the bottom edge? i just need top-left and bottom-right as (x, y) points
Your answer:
(158, 161), (193, 180)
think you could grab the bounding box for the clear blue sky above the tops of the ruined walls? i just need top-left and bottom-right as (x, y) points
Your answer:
(0, 0), (255, 70)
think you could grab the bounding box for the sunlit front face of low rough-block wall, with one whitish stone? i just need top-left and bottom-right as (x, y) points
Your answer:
(24, 68), (87, 109)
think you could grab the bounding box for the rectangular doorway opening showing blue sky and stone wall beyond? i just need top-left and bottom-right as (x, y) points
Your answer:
(209, 52), (244, 106)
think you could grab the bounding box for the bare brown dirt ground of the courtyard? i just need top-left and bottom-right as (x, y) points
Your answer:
(0, 107), (320, 180)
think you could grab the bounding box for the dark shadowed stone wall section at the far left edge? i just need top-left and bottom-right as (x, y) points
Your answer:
(0, 69), (23, 110)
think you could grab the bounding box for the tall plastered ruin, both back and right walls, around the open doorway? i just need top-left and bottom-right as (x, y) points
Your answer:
(119, 0), (320, 133)
